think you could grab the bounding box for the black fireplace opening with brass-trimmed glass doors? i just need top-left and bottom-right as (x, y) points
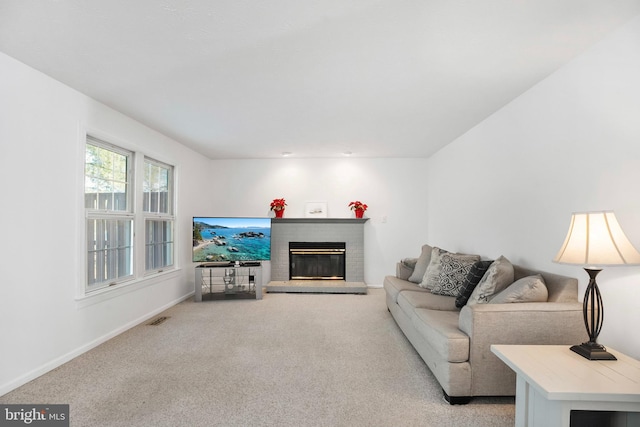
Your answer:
(289, 242), (346, 280)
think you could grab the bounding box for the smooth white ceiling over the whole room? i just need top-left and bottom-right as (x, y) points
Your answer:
(0, 0), (640, 158)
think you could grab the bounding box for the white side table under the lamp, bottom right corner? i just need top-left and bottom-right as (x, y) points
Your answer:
(491, 345), (640, 427)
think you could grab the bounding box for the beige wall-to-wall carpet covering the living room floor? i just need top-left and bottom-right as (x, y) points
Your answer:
(0, 289), (515, 427)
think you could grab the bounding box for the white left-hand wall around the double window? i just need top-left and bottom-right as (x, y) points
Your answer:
(0, 53), (209, 395)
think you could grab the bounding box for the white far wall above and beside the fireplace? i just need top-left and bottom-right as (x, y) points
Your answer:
(201, 158), (427, 286)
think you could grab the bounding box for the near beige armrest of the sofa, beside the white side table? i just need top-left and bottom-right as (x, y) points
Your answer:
(458, 302), (588, 396)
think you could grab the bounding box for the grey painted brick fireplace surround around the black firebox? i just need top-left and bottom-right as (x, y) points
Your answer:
(267, 218), (367, 293)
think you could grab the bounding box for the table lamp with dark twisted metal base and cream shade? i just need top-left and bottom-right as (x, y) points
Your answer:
(553, 211), (640, 360)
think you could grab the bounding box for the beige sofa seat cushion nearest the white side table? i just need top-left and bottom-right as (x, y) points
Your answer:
(411, 308), (469, 363)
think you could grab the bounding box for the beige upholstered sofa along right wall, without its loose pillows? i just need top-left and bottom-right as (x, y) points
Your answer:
(384, 247), (587, 404)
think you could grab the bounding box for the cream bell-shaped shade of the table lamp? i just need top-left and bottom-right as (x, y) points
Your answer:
(553, 211), (640, 266)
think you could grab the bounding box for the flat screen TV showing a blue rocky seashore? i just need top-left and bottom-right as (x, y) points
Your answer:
(193, 217), (271, 262)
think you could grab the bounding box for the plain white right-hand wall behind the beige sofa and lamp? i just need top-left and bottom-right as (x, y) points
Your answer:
(426, 16), (640, 358)
